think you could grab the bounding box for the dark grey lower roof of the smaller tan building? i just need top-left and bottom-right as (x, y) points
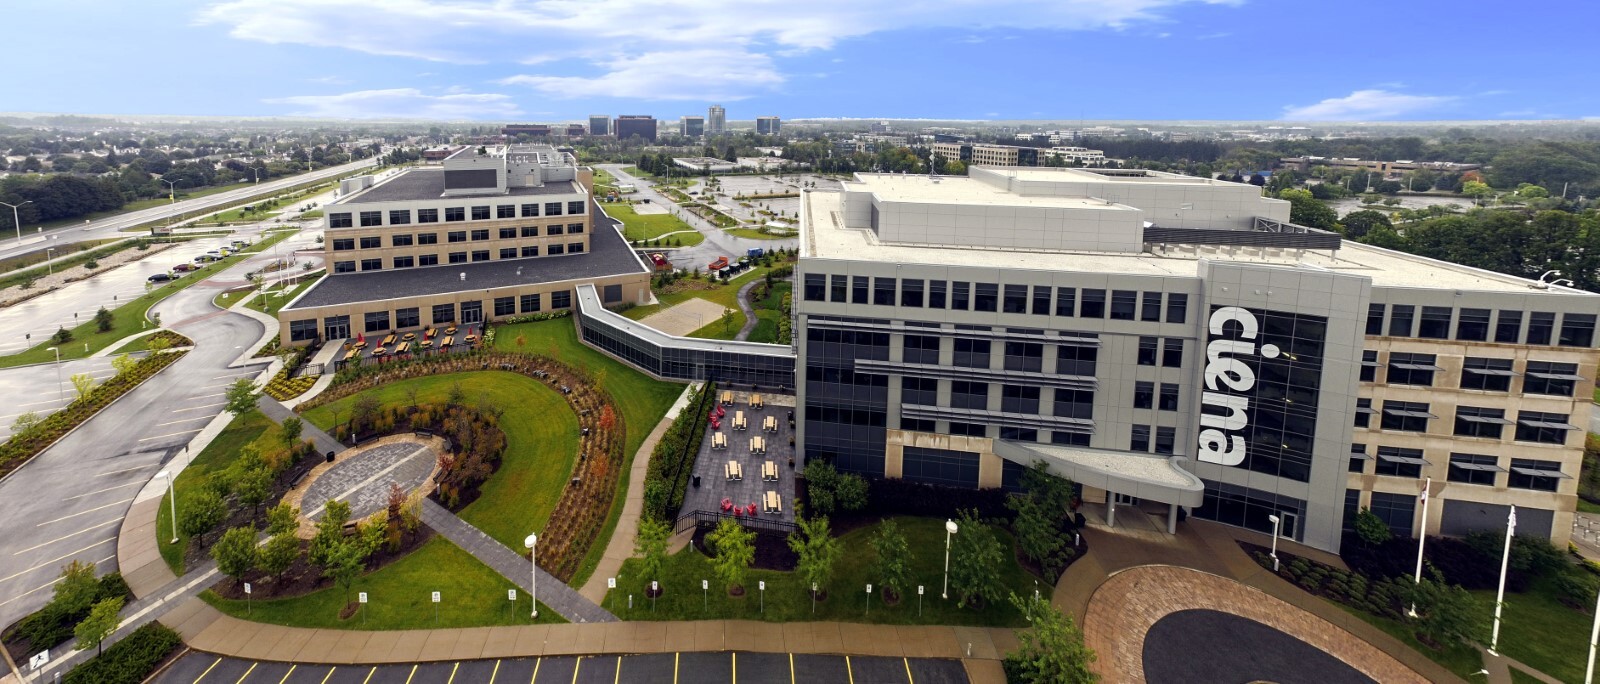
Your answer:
(283, 206), (648, 312)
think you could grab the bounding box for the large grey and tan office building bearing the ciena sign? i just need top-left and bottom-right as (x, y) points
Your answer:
(794, 166), (1600, 551)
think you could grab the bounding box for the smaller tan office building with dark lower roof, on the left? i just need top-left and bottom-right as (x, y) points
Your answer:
(278, 145), (650, 345)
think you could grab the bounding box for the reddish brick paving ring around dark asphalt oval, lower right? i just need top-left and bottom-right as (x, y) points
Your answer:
(1083, 566), (1427, 684)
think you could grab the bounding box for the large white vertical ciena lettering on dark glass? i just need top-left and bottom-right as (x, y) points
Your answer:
(1197, 307), (1278, 465)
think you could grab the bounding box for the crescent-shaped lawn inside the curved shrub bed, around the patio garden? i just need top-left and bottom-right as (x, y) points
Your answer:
(306, 371), (578, 548)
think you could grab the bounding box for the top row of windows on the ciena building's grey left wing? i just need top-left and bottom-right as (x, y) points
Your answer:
(803, 273), (1189, 323)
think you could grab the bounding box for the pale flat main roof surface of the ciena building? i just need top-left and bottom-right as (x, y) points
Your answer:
(800, 189), (1595, 296)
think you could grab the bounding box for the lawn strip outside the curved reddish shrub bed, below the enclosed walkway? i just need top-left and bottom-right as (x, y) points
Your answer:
(494, 318), (683, 587)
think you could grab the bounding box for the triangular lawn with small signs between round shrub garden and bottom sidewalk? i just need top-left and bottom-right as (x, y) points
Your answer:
(200, 537), (566, 630)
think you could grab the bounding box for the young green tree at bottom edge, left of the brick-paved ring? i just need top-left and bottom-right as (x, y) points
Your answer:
(1005, 595), (1099, 684)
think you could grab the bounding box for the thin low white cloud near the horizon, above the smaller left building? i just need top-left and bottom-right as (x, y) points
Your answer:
(264, 88), (522, 120)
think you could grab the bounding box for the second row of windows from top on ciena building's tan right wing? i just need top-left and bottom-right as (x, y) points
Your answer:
(1362, 350), (1582, 396)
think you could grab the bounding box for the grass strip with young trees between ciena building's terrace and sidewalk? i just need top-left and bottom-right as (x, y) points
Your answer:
(603, 518), (1051, 626)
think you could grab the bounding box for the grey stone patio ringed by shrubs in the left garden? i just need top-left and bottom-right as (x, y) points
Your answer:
(283, 435), (445, 532)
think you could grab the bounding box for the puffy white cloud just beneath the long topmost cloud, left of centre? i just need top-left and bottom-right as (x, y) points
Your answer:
(499, 48), (784, 101)
